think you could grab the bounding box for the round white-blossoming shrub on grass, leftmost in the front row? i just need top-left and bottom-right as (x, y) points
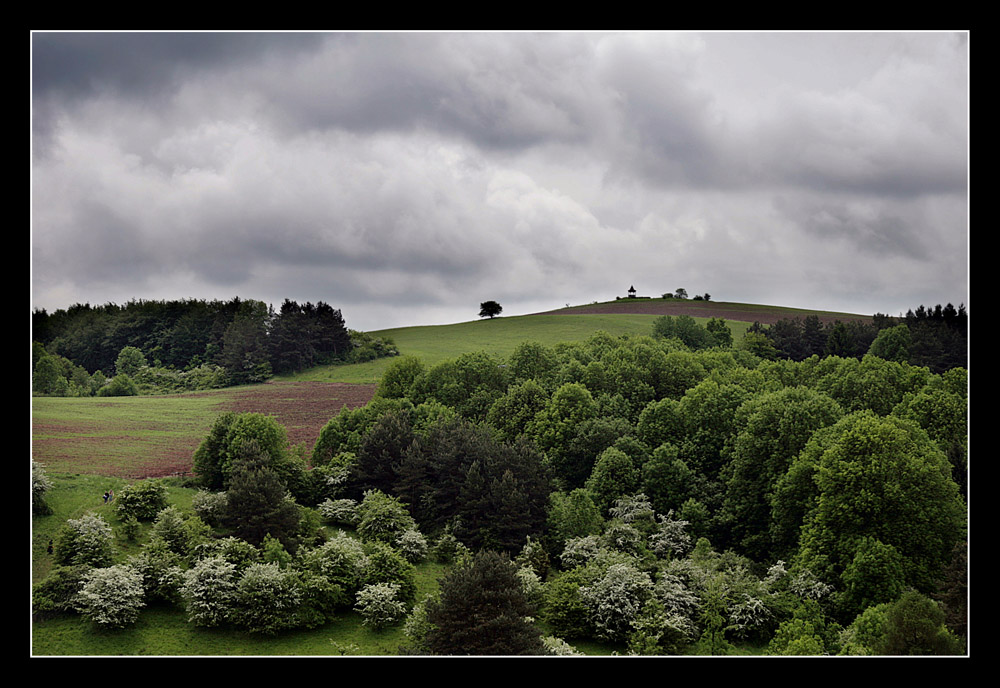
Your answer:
(76, 565), (146, 628)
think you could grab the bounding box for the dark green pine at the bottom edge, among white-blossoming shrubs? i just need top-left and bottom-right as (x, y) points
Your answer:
(425, 551), (542, 655)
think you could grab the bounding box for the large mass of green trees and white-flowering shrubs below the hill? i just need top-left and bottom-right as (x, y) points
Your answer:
(36, 314), (968, 655)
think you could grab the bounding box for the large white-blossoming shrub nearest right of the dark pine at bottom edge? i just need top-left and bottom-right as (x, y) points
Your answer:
(580, 564), (653, 642)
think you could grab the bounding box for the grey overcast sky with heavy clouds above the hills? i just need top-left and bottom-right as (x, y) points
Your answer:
(31, 32), (969, 330)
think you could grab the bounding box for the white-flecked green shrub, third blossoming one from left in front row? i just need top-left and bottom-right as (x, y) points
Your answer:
(232, 563), (302, 635)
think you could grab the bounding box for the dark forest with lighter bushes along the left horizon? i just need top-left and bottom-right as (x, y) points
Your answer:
(32, 298), (397, 396)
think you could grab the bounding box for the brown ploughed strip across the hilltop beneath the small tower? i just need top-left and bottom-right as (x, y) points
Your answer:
(538, 299), (871, 325)
